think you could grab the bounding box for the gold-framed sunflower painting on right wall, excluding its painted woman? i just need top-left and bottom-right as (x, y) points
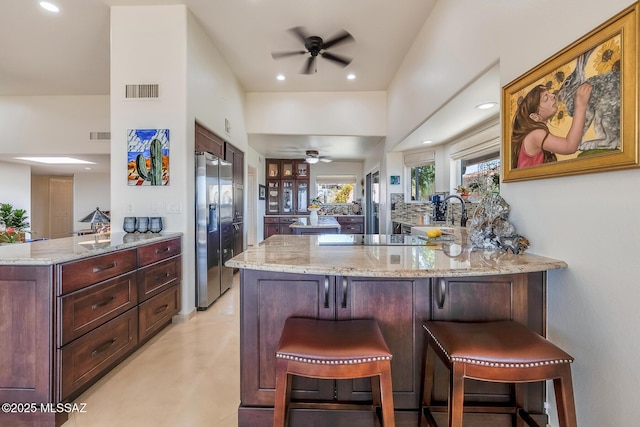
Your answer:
(502, 3), (640, 182)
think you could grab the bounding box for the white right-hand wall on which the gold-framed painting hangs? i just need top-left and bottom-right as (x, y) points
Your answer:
(387, 0), (640, 427)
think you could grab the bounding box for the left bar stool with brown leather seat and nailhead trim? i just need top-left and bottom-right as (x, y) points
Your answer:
(273, 317), (395, 427)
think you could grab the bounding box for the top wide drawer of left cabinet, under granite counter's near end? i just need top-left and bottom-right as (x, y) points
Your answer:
(58, 249), (137, 295)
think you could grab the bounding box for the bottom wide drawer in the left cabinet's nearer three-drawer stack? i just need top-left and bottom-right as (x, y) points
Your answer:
(60, 307), (138, 400)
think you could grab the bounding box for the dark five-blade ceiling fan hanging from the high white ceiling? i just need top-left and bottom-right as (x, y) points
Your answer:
(271, 27), (355, 74)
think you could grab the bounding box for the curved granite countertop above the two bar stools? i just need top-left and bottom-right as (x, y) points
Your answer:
(225, 234), (567, 277)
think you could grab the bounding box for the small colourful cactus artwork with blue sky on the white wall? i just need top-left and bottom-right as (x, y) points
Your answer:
(127, 129), (169, 186)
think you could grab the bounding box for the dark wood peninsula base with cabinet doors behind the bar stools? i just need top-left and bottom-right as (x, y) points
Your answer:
(238, 269), (547, 427)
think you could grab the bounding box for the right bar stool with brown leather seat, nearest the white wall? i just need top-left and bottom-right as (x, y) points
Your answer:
(420, 321), (577, 427)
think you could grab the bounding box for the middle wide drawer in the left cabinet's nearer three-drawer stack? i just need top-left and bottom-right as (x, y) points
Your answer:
(59, 273), (138, 346)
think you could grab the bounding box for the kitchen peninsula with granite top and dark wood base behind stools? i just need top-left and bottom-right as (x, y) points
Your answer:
(227, 234), (567, 427)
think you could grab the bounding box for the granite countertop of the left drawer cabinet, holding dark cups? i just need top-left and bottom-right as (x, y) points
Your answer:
(0, 232), (182, 265)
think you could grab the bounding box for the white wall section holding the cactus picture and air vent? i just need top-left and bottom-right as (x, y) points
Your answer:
(110, 6), (194, 313)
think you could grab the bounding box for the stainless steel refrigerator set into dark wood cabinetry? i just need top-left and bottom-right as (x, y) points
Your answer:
(195, 152), (233, 310)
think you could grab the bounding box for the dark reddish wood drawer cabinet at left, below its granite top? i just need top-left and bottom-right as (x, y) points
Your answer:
(0, 238), (182, 427)
